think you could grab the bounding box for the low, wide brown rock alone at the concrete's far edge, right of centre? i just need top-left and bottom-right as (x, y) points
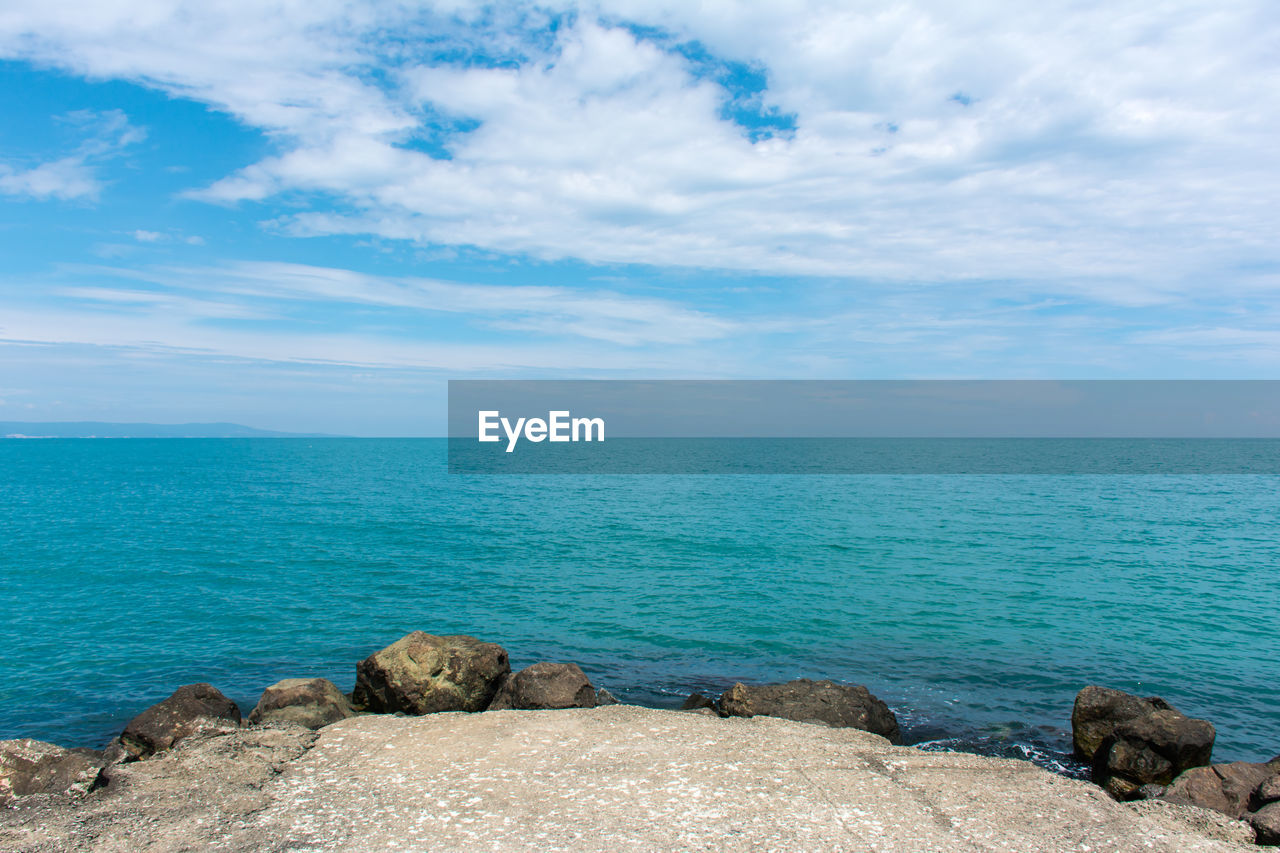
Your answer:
(719, 679), (902, 743)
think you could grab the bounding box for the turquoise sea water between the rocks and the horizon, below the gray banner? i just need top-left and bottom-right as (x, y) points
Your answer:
(0, 439), (1280, 760)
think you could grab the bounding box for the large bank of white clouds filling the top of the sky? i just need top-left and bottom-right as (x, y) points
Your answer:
(0, 0), (1280, 295)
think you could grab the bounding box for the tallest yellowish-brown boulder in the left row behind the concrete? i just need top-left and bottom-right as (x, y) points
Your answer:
(351, 631), (511, 715)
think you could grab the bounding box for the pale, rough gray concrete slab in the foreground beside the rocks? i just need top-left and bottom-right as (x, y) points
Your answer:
(0, 706), (1252, 853)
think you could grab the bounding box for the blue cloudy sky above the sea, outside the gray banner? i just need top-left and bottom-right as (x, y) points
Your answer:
(0, 0), (1280, 435)
